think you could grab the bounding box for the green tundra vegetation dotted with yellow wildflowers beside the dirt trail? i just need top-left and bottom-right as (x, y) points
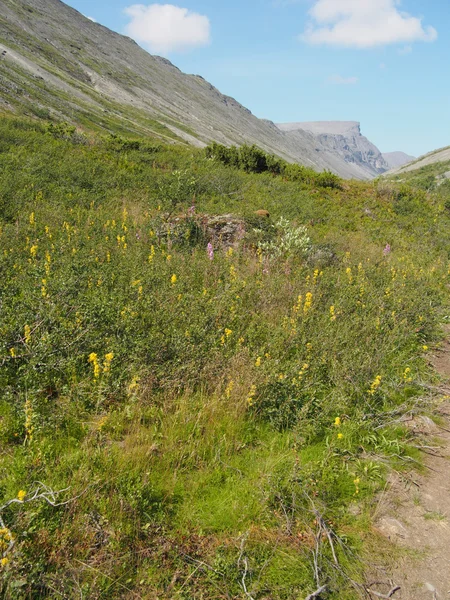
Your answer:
(0, 116), (450, 600)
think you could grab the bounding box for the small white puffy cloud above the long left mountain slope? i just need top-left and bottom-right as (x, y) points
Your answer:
(125, 4), (211, 54)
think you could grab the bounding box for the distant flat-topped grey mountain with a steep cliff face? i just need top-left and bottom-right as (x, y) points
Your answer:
(278, 121), (389, 179)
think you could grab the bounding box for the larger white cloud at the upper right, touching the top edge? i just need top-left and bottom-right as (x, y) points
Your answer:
(301, 0), (437, 48)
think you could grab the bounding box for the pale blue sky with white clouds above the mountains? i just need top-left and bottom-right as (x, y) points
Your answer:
(62, 0), (450, 156)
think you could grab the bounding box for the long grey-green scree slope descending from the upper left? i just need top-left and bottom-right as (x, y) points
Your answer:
(0, 0), (384, 179)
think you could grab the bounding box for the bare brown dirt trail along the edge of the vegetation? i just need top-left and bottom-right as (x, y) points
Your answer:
(373, 328), (450, 600)
